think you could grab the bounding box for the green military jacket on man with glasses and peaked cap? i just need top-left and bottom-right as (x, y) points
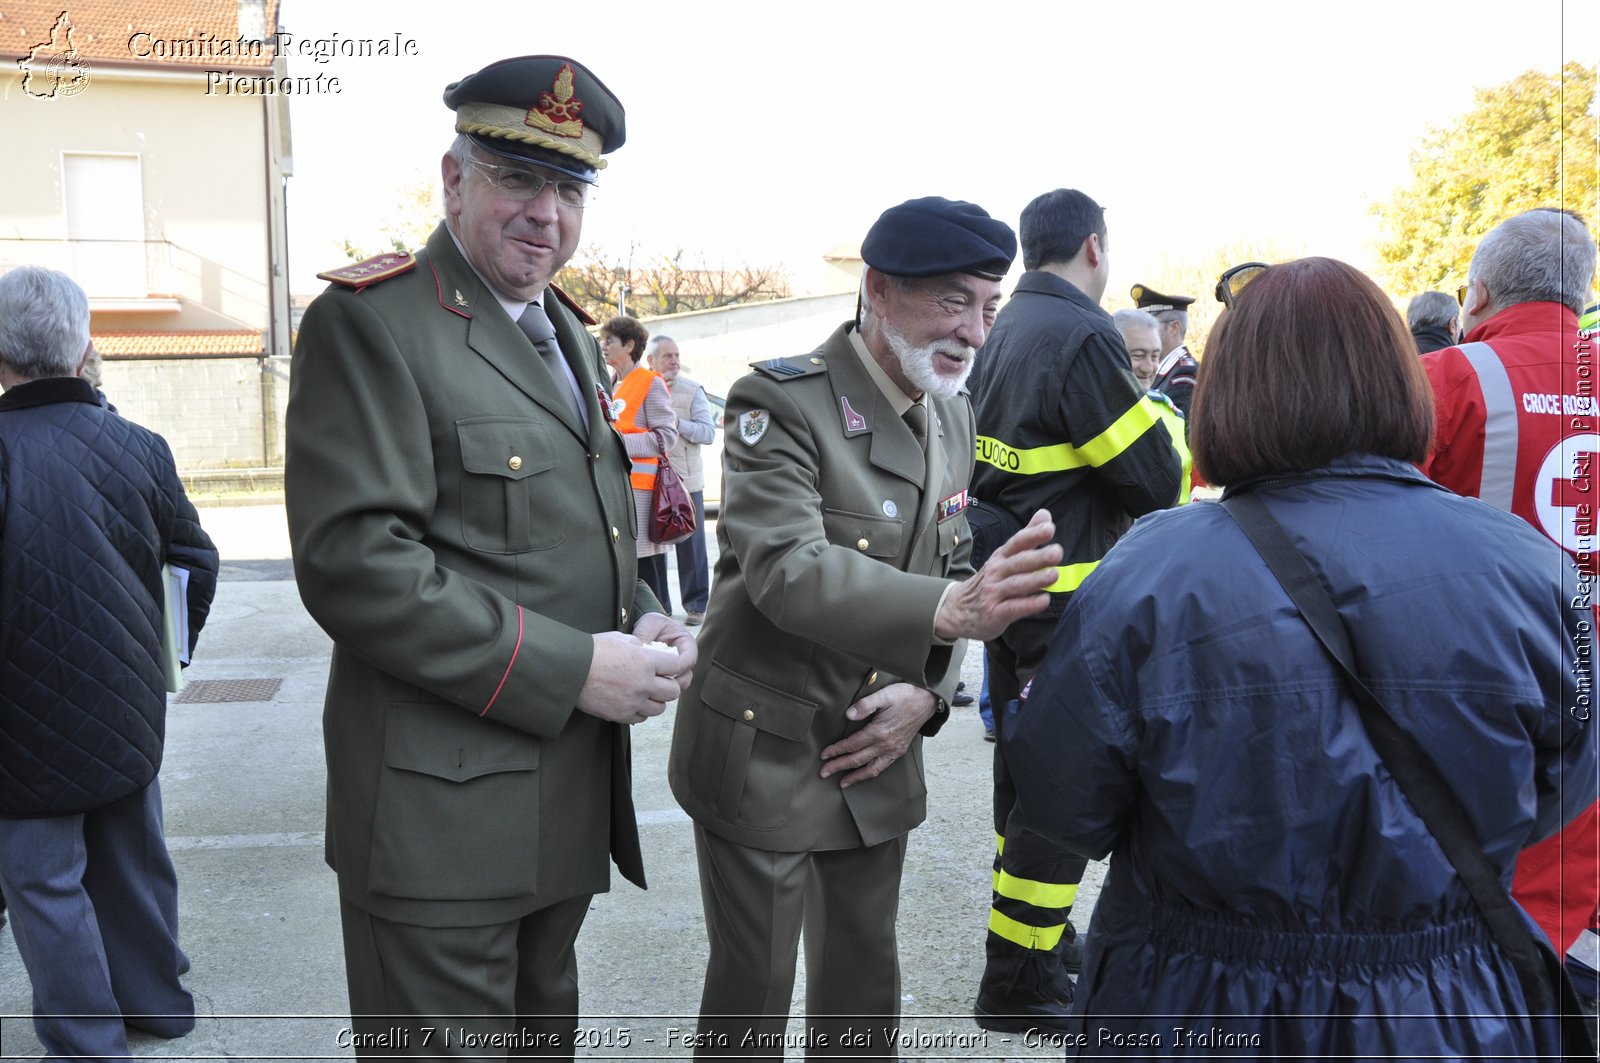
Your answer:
(285, 226), (661, 925)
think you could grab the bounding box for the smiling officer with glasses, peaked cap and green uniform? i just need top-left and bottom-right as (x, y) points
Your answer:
(286, 56), (696, 1058)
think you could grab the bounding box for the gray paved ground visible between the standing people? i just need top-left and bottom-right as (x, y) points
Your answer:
(0, 506), (1101, 1060)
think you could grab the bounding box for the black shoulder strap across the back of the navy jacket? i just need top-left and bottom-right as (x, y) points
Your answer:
(1222, 495), (1555, 1013)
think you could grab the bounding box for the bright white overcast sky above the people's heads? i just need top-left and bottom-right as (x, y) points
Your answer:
(280, 0), (1600, 304)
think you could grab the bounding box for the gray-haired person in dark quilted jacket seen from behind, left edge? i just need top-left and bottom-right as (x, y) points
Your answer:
(0, 267), (218, 1060)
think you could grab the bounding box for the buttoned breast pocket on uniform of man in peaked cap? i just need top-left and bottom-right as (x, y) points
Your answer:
(456, 418), (566, 554)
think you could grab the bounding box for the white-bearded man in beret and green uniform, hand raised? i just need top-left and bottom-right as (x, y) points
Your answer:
(670, 197), (1059, 1058)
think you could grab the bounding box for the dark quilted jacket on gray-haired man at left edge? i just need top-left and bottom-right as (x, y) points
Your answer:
(0, 378), (218, 816)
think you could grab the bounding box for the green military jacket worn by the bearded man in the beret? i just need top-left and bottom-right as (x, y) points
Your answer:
(669, 325), (974, 852)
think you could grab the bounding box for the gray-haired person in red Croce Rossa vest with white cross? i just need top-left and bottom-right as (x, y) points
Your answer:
(1422, 208), (1600, 998)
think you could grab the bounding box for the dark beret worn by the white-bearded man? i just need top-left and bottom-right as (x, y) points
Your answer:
(861, 195), (1016, 280)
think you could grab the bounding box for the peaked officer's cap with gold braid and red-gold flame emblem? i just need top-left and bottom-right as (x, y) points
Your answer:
(445, 56), (626, 181)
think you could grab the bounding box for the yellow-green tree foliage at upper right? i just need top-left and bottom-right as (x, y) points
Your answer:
(1374, 62), (1600, 295)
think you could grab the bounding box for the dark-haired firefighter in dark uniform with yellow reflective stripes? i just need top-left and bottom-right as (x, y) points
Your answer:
(971, 189), (1182, 1033)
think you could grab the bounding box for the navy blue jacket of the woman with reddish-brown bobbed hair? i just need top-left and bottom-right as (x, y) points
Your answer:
(1006, 456), (1597, 1058)
